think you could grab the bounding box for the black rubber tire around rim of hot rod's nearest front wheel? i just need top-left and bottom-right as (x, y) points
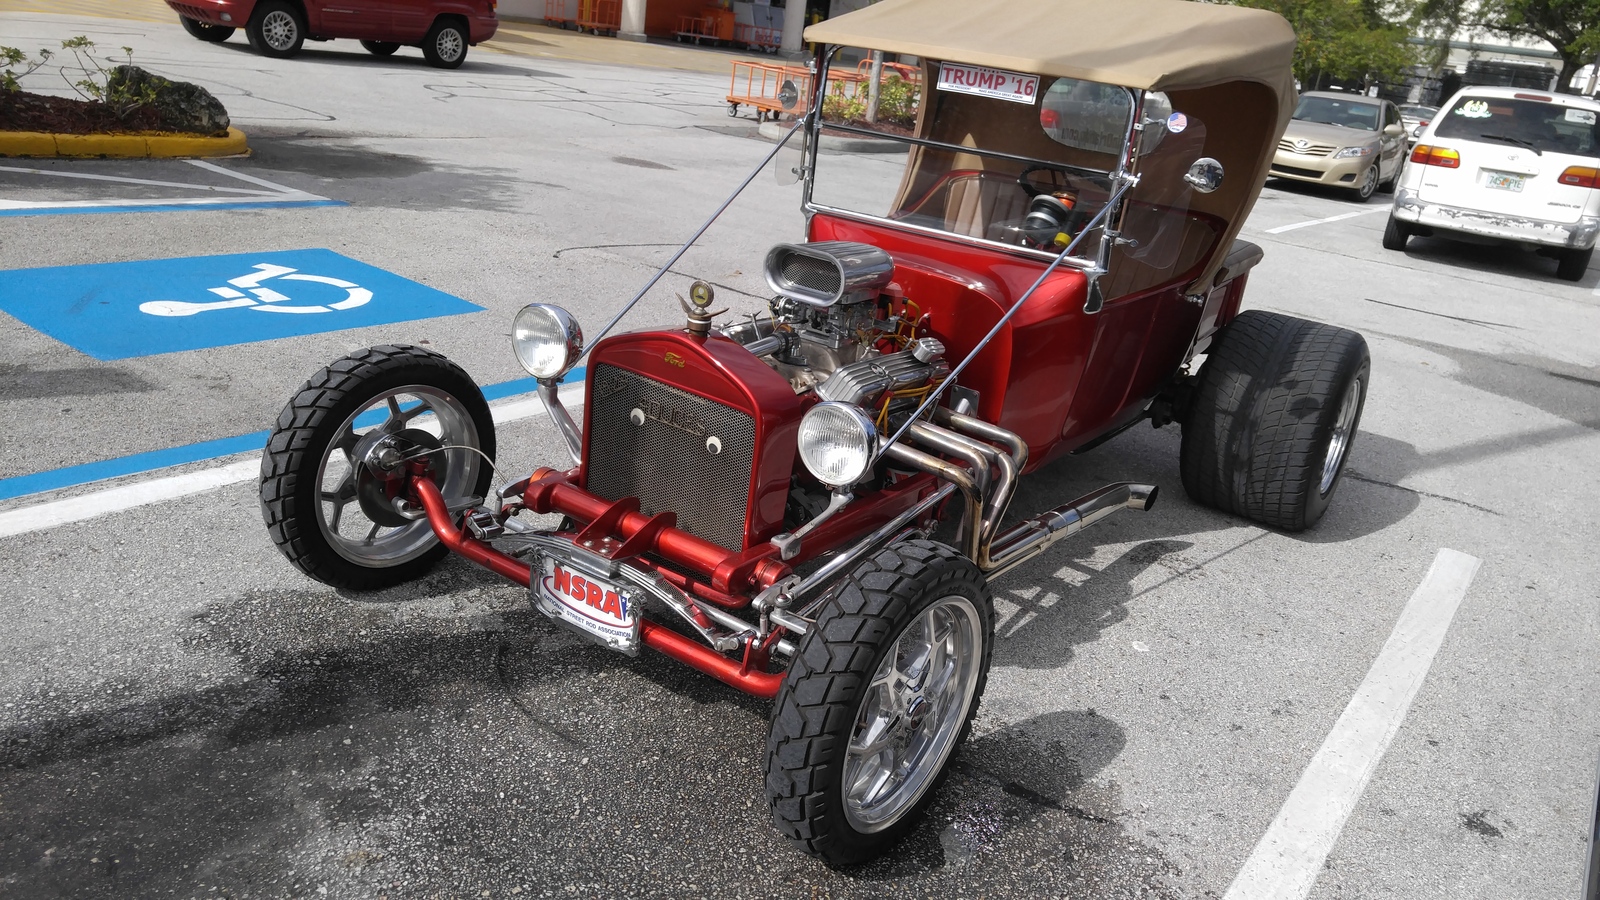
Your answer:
(766, 541), (994, 866)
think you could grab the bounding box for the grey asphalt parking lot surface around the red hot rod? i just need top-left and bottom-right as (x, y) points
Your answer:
(0, 13), (1600, 900)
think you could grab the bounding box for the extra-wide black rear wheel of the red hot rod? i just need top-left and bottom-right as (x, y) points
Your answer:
(1179, 311), (1371, 532)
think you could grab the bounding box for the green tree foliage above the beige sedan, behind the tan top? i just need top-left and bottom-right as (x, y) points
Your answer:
(1232, 0), (1414, 88)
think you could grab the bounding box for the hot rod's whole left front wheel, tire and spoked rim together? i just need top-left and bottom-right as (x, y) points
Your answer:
(261, 346), (494, 591)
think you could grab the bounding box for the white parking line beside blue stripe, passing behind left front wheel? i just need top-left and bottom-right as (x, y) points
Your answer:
(0, 391), (584, 538)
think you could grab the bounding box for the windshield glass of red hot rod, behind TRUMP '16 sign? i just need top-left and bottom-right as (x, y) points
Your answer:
(811, 50), (1133, 259)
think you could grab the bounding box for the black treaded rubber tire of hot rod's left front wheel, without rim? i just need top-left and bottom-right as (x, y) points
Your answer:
(261, 344), (494, 591)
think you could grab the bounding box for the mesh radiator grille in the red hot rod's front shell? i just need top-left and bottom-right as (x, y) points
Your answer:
(584, 364), (755, 549)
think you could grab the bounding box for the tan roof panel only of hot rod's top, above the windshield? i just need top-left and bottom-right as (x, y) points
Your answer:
(805, 0), (1294, 119)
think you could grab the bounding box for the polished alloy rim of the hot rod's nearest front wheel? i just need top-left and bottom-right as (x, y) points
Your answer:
(842, 596), (982, 833)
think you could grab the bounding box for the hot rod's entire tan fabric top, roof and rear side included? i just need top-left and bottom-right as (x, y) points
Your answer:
(812, 0), (1296, 293)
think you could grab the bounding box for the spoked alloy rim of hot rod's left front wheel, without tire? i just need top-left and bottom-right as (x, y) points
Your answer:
(317, 384), (485, 567)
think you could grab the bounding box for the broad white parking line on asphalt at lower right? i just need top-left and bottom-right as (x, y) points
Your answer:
(1222, 548), (1483, 900)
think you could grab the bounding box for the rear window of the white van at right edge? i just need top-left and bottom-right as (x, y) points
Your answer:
(1434, 94), (1600, 157)
